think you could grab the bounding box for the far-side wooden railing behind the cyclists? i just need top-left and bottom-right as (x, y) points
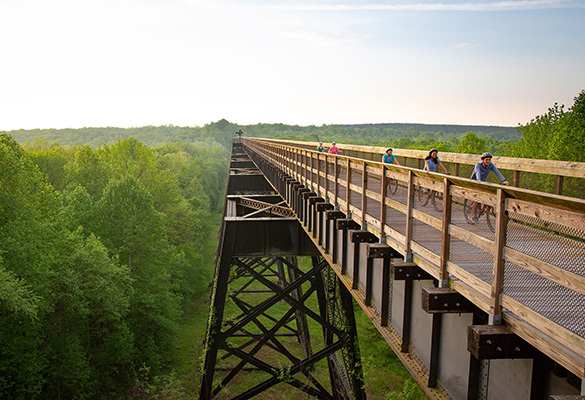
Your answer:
(264, 139), (585, 195)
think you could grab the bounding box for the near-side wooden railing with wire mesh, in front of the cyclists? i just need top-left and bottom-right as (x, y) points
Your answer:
(242, 138), (585, 377)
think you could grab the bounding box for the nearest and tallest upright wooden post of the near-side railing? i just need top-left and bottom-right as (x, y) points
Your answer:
(489, 189), (508, 325)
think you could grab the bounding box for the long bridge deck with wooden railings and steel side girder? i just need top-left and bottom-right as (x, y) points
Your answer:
(202, 138), (585, 399)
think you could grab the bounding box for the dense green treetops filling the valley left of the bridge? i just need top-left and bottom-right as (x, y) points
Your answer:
(0, 134), (228, 399)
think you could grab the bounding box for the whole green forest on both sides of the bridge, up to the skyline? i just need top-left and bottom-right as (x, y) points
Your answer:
(0, 91), (585, 399)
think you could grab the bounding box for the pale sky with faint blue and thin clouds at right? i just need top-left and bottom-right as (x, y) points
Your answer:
(0, 0), (585, 131)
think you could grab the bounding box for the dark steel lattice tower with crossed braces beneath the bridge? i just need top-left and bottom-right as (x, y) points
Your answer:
(199, 140), (365, 399)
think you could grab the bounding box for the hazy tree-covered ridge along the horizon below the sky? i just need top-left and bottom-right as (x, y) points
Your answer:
(3, 119), (521, 147)
